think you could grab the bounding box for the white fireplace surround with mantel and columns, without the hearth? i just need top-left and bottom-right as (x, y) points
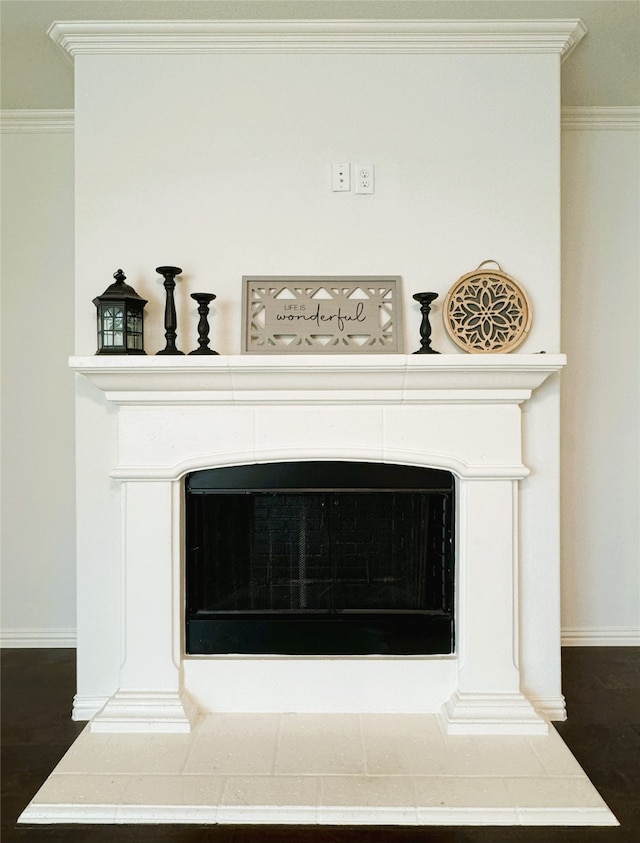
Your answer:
(71, 354), (565, 734)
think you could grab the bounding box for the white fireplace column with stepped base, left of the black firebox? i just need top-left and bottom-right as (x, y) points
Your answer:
(91, 480), (191, 732)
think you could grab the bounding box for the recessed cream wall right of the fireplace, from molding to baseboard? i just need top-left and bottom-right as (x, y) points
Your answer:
(562, 109), (640, 644)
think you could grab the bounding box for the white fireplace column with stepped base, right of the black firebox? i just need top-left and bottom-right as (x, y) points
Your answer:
(442, 478), (548, 735)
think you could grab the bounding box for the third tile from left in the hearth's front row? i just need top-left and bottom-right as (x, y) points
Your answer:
(218, 776), (320, 823)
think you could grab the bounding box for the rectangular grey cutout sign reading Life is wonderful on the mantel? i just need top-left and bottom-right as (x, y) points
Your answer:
(242, 276), (402, 354)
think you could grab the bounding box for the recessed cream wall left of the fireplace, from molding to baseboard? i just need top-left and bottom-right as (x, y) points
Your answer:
(2, 112), (76, 646)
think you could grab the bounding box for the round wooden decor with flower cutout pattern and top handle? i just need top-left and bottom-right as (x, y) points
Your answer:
(442, 260), (531, 354)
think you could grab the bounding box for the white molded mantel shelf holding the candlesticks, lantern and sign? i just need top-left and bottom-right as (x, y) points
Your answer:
(70, 354), (566, 404)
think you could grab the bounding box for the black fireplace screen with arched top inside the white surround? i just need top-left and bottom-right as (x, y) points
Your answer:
(186, 462), (454, 655)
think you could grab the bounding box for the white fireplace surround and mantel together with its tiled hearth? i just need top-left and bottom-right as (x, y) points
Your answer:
(21, 355), (616, 825)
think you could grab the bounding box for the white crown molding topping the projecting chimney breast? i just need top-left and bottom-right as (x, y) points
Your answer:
(48, 19), (587, 60)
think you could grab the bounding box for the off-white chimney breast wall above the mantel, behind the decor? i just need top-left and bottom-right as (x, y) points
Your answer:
(75, 53), (560, 354)
